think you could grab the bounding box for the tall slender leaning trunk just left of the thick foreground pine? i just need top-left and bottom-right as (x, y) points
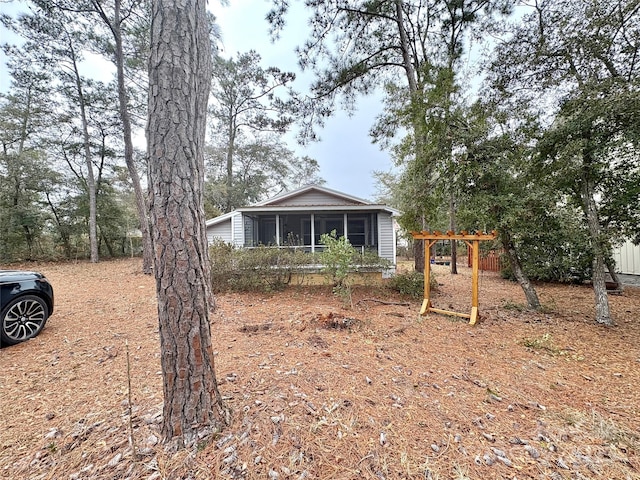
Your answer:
(110, 0), (153, 274)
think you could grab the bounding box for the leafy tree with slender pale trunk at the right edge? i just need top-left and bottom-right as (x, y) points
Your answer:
(484, 0), (640, 325)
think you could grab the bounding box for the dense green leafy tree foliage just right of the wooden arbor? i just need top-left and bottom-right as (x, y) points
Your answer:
(459, 100), (591, 281)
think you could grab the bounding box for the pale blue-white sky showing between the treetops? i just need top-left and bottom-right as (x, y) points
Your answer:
(0, 0), (392, 200)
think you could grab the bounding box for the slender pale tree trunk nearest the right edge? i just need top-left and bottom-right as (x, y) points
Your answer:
(582, 173), (613, 325)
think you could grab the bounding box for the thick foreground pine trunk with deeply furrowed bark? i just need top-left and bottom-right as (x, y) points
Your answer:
(147, 0), (225, 447)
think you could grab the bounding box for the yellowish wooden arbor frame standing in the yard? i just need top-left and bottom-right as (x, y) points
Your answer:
(411, 230), (498, 325)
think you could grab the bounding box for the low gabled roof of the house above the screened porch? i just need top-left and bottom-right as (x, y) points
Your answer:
(207, 185), (400, 227)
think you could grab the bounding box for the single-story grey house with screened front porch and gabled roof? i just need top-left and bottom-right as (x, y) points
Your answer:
(207, 185), (400, 276)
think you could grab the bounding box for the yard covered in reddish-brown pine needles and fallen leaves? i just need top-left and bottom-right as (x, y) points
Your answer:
(0, 260), (640, 480)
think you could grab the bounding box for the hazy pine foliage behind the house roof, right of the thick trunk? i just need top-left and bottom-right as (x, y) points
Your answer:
(206, 50), (322, 212)
